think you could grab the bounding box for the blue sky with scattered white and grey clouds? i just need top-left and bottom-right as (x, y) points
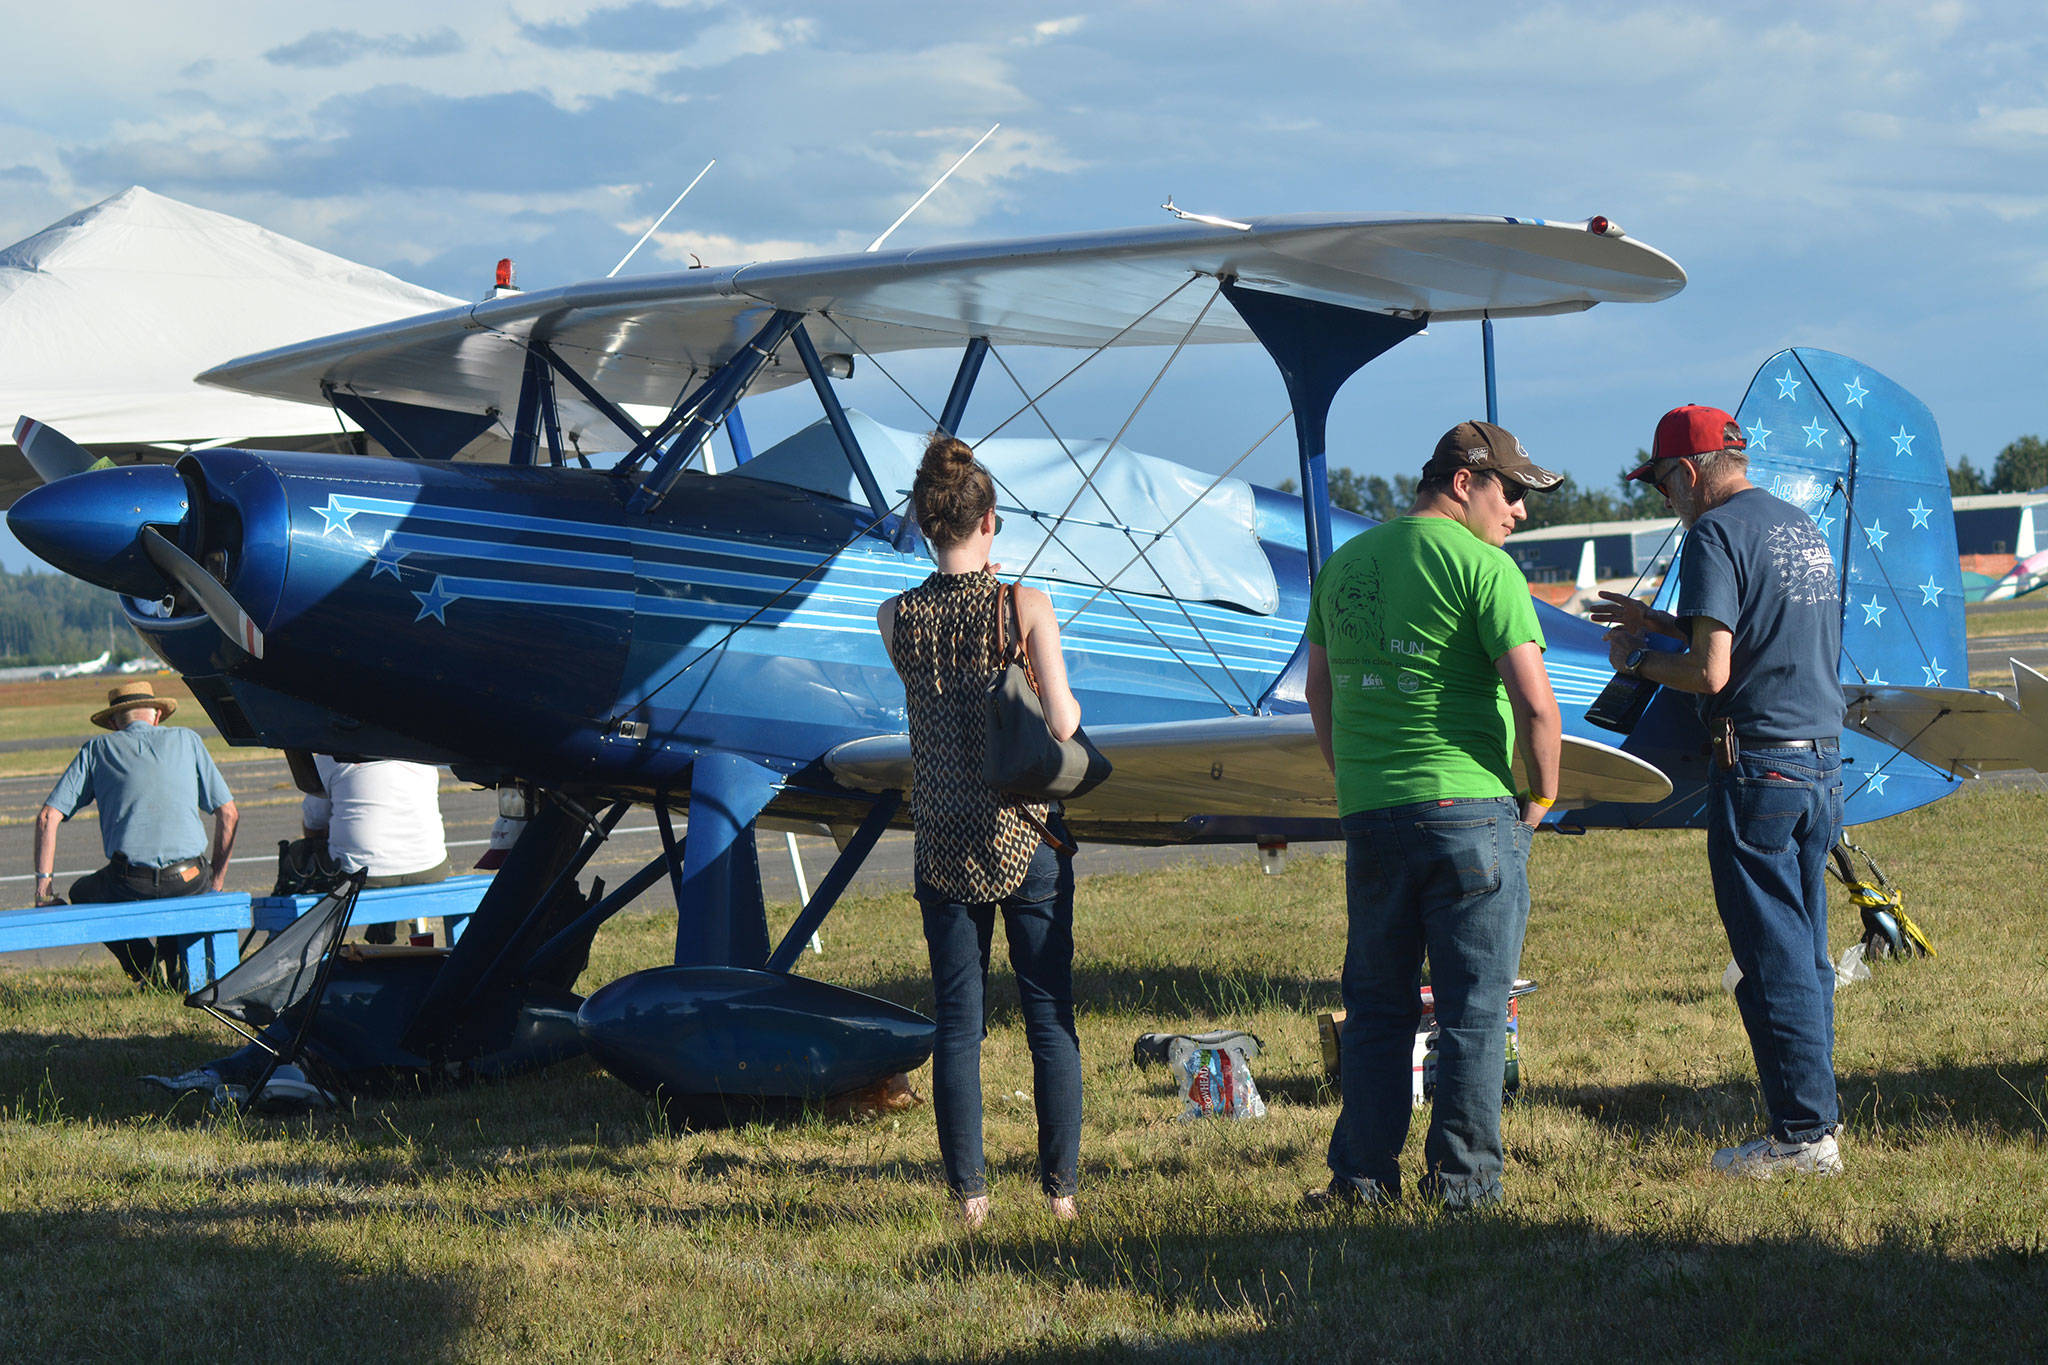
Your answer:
(0, 0), (2048, 567)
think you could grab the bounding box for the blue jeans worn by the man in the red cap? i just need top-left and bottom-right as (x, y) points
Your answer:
(1706, 743), (1841, 1142)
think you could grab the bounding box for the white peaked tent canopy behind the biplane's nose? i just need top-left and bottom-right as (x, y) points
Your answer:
(0, 186), (461, 499)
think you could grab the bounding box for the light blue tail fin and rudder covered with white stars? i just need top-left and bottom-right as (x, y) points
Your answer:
(1657, 346), (1970, 825)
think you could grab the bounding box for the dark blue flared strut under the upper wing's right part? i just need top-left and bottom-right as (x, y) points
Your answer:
(1223, 280), (1430, 577)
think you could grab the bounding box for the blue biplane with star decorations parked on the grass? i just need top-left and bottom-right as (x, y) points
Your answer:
(10, 215), (2048, 1101)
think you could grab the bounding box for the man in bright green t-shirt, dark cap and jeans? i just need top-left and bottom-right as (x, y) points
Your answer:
(1307, 422), (1565, 1207)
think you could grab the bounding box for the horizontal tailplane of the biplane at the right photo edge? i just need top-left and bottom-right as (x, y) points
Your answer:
(1843, 659), (2048, 776)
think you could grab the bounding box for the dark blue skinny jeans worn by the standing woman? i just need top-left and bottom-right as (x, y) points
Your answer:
(918, 843), (1081, 1199)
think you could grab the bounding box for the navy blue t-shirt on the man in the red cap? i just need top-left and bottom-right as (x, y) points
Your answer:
(1677, 489), (1841, 739)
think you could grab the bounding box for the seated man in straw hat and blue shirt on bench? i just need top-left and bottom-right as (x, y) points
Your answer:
(35, 681), (240, 984)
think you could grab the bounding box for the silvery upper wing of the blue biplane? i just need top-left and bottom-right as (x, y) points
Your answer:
(199, 215), (1686, 423)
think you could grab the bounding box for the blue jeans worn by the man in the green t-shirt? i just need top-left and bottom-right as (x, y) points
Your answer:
(1329, 796), (1532, 1207)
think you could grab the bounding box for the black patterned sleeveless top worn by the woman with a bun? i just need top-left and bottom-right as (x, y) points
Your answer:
(893, 569), (1047, 902)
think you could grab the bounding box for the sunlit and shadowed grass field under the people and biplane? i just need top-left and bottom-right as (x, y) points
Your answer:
(0, 788), (2048, 1363)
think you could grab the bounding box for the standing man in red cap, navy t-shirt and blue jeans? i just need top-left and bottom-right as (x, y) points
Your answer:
(1591, 405), (1843, 1179)
